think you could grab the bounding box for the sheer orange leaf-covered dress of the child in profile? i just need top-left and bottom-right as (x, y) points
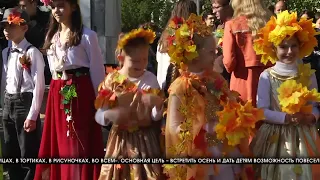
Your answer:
(164, 71), (241, 180)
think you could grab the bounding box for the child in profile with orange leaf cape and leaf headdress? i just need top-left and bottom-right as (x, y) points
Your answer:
(164, 14), (255, 180)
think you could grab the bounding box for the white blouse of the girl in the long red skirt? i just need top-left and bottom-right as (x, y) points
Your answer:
(47, 27), (105, 95)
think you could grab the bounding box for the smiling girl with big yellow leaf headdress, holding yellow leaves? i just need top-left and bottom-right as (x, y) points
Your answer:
(251, 11), (320, 180)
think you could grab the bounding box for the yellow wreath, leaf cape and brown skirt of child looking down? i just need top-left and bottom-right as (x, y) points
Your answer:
(95, 29), (163, 180)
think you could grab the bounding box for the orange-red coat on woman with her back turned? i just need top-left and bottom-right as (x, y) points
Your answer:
(223, 16), (268, 105)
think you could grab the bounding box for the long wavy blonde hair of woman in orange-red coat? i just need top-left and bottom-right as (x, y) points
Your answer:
(231, 0), (272, 36)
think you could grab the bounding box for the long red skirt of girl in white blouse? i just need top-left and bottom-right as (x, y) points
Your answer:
(35, 75), (104, 180)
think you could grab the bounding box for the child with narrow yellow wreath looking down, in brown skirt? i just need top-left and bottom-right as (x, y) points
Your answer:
(95, 29), (163, 180)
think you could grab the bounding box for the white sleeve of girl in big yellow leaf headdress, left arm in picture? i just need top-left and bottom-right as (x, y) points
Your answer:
(257, 71), (286, 124)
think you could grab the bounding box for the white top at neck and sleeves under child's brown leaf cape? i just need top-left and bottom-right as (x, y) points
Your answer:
(95, 71), (163, 126)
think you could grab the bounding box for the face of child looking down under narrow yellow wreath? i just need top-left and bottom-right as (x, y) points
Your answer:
(123, 45), (149, 77)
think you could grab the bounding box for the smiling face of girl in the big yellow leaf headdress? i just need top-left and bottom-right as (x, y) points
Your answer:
(276, 36), (299, 64)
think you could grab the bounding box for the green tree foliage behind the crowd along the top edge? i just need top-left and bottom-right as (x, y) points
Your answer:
(121, 0), (320, 31)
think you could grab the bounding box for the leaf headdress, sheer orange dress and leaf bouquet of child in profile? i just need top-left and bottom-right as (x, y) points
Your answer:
(164, 14), (263, 180)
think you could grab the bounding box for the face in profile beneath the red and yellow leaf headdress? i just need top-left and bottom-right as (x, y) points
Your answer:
(198, 36), (216, 70)
